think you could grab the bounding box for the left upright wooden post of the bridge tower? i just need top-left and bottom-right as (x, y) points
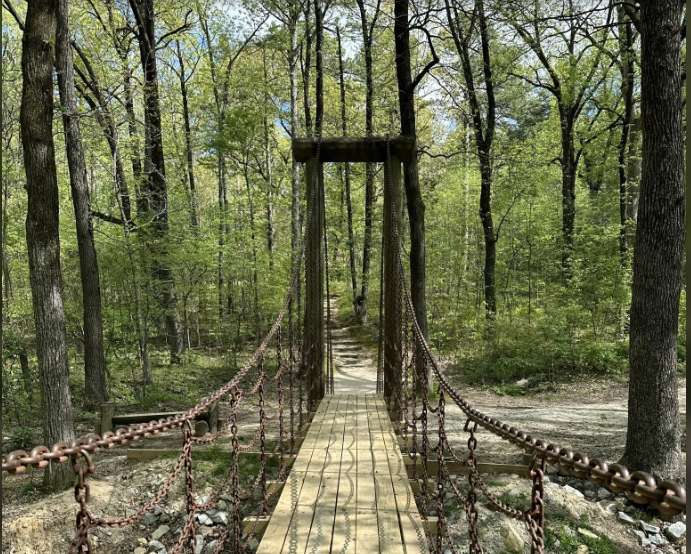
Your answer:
(302, 156), (326, 411)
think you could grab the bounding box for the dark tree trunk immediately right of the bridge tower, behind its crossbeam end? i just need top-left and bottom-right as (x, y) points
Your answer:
(394, 0), (432, 387)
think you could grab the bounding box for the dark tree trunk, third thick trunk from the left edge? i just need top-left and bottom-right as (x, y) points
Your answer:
(130, 0), (185, 363)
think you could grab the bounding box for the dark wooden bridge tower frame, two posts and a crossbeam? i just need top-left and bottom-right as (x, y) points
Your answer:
(292, 136), (415, 412)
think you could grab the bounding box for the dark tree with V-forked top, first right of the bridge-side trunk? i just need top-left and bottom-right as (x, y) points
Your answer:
(446, 0), (499, 319)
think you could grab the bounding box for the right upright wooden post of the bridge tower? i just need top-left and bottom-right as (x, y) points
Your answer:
(382, 155), (403, 421)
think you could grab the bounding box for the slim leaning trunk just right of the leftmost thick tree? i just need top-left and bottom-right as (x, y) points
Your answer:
(55, 0), (108, 408)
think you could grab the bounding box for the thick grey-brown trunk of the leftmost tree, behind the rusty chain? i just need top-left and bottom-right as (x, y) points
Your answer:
(20, 0), (75, 491)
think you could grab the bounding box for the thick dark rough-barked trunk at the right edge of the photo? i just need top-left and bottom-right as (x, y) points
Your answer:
(622, 0), (686, 479)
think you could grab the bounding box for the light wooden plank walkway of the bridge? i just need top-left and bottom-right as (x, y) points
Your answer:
(257, 394), (428, 554)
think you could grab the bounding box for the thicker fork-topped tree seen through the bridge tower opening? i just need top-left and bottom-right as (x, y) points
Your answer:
(357, 0), (381, 319)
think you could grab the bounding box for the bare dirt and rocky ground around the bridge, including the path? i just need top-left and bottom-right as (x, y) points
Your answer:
(2, 302), (686, 554)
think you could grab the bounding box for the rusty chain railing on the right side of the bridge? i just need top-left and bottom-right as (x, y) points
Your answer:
(377, 136), (686, 554)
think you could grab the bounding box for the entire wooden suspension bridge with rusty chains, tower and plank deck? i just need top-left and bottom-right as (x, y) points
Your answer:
(2, 137), (686, 554)
